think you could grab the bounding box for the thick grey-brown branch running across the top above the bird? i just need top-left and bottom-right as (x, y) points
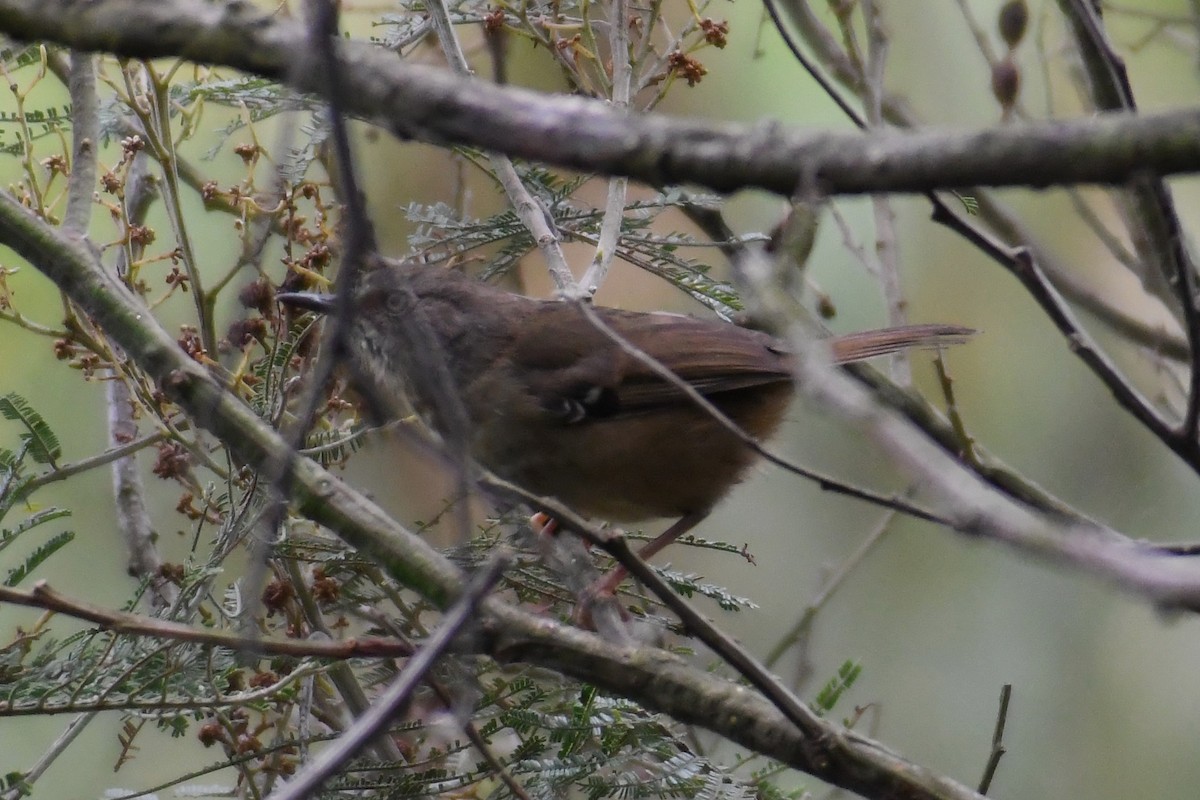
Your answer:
(0, 0), (1200, 196)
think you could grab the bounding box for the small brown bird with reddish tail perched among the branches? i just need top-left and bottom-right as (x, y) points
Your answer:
(277, 263), (973, 578)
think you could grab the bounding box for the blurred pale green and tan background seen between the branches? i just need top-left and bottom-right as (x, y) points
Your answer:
(0, 0), (1200, 800)
